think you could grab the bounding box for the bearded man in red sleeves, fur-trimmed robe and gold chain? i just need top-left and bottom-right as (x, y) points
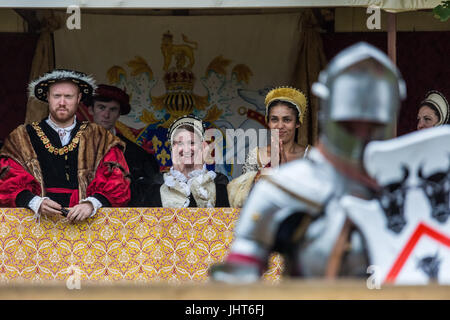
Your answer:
(0, 69), (130, 221)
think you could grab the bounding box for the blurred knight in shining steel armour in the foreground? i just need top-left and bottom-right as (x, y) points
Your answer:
(210, 43), (406, 283)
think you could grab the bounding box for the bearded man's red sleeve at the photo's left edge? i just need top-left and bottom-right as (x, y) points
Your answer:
(0, 157), (41, 208)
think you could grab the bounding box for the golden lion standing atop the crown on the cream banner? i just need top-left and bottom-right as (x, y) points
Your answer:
(161, 31), (197, 71)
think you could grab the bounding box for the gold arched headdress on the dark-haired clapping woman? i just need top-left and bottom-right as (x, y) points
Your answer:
(264, 87), (308, 123)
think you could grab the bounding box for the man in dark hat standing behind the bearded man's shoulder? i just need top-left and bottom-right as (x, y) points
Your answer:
(87, 84), (159, 207)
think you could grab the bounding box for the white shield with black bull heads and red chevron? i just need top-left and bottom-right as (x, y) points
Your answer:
(341, 126), (450, 285)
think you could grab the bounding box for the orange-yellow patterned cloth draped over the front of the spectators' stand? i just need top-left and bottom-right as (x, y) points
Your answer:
(0, 208), (282, 282)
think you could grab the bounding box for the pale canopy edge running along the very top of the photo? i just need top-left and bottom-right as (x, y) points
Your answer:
(0, 0), (441, 12)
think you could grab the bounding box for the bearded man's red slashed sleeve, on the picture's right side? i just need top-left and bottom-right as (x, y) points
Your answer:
(86, 147), (131, 207)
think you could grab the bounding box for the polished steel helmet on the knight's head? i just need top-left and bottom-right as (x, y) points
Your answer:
(312, 42), (406, 165)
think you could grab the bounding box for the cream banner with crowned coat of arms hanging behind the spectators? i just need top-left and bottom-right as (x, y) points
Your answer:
(55, 13), (300, 178)
